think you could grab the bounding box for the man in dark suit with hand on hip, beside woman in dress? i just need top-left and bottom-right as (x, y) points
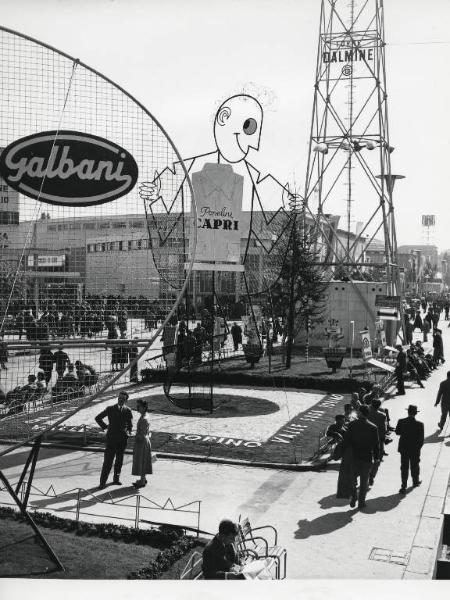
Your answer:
(95, 391), (133, 490)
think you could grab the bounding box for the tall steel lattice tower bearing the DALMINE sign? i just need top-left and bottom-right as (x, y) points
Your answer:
(305, 0), (401, 294)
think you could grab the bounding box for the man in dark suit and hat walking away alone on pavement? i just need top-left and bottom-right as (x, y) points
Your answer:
(395, 404), (424, 494)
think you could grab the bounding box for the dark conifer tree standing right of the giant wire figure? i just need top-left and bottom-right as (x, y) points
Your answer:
(271, 209), (327, 369)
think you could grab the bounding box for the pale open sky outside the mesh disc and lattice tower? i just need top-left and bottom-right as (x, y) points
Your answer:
(1, 0), (450, 249)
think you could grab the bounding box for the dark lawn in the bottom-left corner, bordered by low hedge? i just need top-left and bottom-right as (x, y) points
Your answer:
(0, 518), (160, 579)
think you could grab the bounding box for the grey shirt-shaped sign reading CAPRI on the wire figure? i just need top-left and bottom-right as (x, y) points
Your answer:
(192, 163), (244, 270)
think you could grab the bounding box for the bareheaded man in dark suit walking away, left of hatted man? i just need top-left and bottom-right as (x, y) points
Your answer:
(344, 405), (380, 508)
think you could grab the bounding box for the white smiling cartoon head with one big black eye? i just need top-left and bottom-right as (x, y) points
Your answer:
(214, 94), (263, 163)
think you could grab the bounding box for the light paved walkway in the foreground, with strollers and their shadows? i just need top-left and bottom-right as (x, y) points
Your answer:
(2, 328), (450, 579)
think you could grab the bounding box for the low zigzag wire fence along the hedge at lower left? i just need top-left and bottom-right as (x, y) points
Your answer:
(0, 481), (201, 536)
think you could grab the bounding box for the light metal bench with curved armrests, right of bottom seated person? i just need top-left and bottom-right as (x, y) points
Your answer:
(237, 517), (287, 579)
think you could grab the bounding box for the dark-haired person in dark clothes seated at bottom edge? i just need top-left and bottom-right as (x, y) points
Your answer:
(202, 519), (244, 579)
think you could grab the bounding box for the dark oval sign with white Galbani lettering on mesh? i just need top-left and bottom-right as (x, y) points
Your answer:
(0, 131), (138, 206)
